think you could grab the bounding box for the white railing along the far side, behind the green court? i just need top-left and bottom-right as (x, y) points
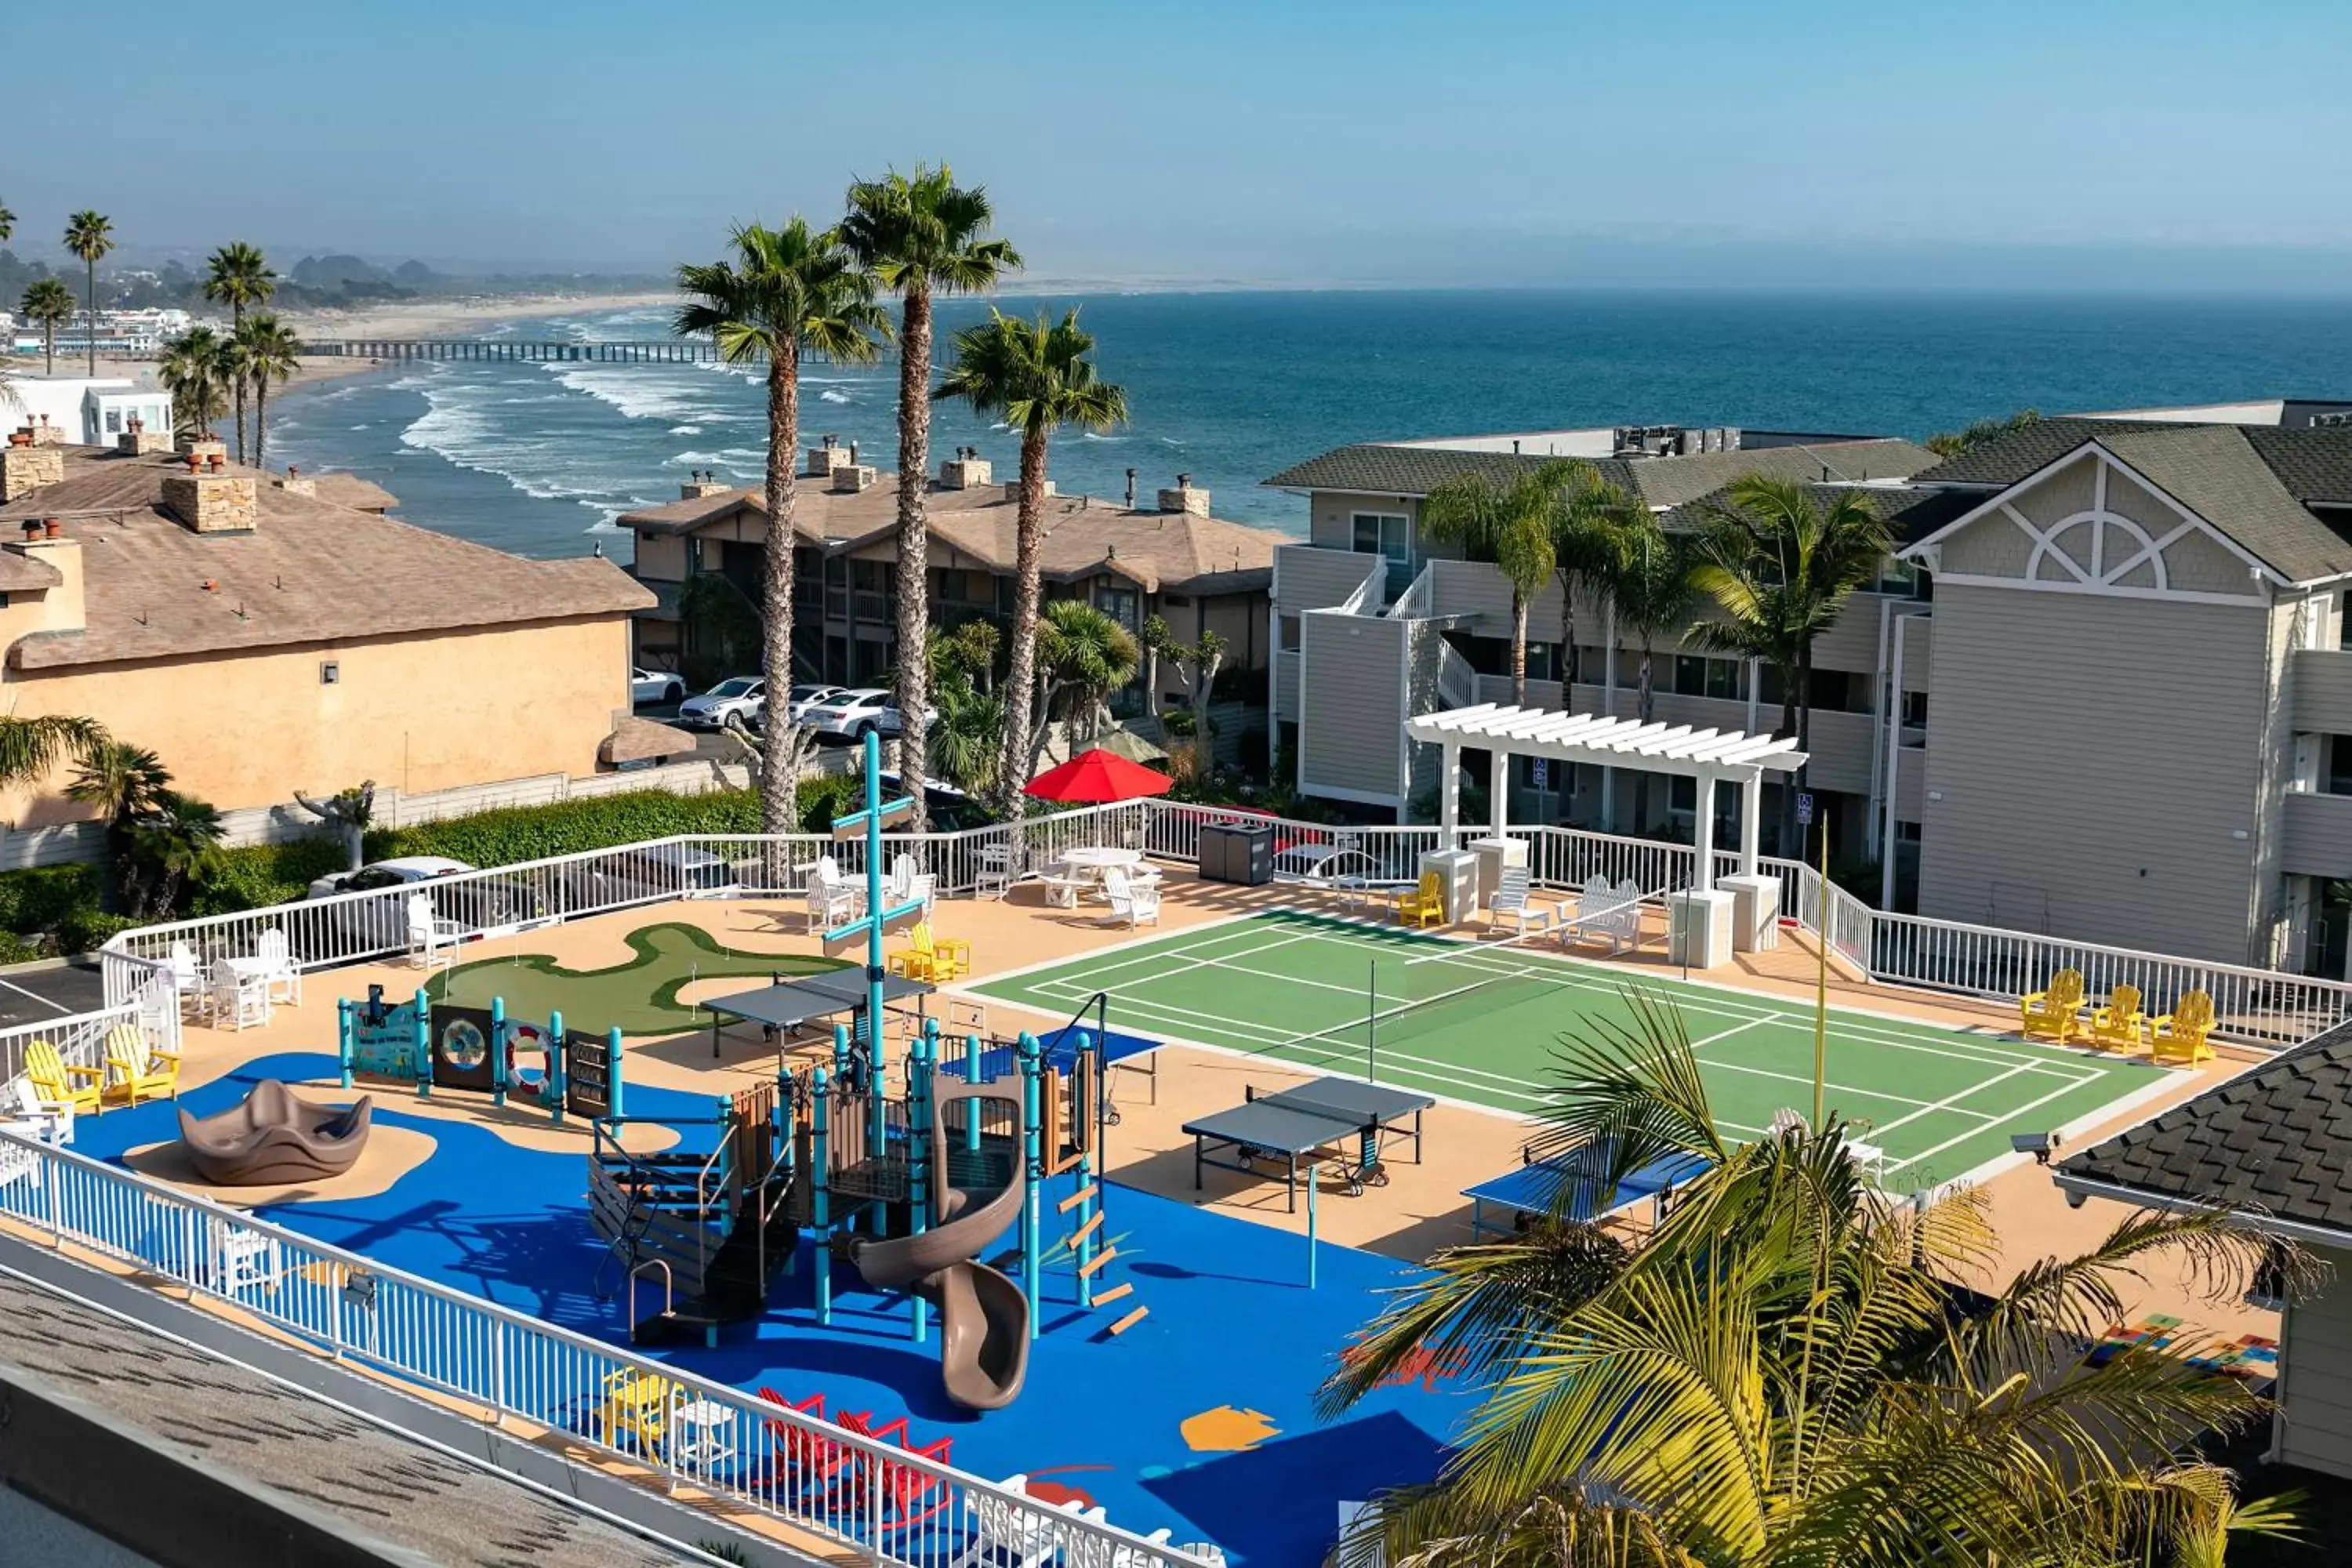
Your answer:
(101, 799), (2352, 1046)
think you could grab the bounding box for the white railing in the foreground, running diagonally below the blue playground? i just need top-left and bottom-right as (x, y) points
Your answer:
(0, 1133), (1200, 1568)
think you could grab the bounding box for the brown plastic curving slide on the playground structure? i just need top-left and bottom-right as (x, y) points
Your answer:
(851, 1079), (1030, 1410)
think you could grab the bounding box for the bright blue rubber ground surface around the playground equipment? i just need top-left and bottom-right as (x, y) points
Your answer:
(75, 1053), (1470, 1566)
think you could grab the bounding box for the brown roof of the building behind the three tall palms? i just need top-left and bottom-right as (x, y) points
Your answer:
(621, 475), (1298, 593)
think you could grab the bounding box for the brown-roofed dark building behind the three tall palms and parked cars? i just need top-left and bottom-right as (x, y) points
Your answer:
(621, 440), (1287, 738)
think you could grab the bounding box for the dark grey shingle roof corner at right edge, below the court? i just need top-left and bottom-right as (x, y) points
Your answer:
(2058, 1025), (2352, 1234)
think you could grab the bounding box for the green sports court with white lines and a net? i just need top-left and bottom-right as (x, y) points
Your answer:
(974, 912), (2164, 1189)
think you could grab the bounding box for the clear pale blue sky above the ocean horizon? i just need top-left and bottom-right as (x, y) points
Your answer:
(13, 0), (2352, 289)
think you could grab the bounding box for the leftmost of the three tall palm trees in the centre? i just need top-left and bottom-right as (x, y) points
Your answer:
(673, 214), (889, 834)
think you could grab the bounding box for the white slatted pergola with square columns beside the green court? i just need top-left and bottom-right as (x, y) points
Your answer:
(1404, 703), (1804, 893)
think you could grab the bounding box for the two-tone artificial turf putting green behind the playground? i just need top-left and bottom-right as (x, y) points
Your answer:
(426, 921), (840, 1034)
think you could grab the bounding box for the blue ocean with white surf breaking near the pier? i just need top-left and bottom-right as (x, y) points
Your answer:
(270, 292), (2352, 557)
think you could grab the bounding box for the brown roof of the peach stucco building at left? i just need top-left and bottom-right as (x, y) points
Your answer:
(0, 454), (654, 670)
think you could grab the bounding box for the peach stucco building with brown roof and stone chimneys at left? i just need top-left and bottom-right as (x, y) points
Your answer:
(0, 433), (649, 827)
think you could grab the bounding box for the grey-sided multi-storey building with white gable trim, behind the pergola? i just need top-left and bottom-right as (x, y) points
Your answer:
(1270, 400), (2352, 975)
